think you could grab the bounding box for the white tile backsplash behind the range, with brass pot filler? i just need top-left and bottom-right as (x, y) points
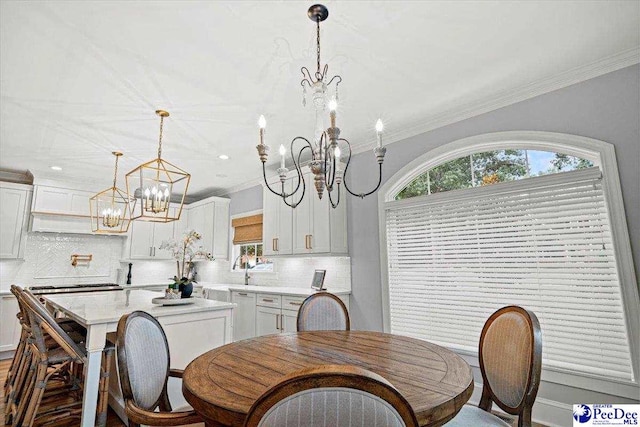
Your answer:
(0, 232), (125, 289)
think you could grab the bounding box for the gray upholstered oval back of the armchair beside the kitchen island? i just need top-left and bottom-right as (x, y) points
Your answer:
(117, 311), (171, 411)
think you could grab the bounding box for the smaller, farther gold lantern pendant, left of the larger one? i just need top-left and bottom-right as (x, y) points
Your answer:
(89, 151), (134, 234)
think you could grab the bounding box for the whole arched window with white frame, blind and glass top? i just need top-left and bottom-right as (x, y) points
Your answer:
(379, 132), (640, 384)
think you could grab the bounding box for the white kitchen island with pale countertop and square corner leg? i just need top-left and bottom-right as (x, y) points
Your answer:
(45, 289), (235, 427)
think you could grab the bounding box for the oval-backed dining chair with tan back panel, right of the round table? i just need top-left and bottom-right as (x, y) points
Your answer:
(446, 306), (542, 427)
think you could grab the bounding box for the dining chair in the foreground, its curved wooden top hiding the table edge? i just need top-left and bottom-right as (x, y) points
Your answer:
(244, 365), (418, 427)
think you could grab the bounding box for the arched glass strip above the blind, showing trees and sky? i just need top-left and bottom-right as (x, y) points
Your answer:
(396, 149), (593, 200)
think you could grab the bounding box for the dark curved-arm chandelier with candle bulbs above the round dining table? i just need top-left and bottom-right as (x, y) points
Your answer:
(256, 4), (387, 208)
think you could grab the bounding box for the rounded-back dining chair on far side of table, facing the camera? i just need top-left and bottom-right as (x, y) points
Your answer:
(297, 292), (351, 332)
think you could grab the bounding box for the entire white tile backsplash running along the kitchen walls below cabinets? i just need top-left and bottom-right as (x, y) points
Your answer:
(0, 232), (351, 290)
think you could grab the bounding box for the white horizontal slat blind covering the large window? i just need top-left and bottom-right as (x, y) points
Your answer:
(385, 168), (633, 380)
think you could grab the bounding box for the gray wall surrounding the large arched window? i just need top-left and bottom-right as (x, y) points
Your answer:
(347, 65), (640, 330)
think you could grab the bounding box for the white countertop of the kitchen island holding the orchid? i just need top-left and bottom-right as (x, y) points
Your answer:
(43, 289), (236, 325)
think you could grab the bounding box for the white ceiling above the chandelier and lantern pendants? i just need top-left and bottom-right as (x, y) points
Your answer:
(0, 1), (640, 197)
